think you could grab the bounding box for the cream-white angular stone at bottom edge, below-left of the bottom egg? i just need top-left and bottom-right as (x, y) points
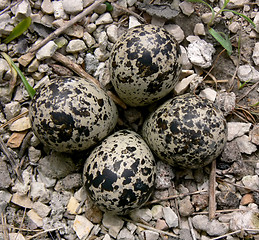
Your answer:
(73, 215), (94, 239)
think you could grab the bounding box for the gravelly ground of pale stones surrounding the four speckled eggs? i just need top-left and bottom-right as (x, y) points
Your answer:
(0, 0), (259, 240)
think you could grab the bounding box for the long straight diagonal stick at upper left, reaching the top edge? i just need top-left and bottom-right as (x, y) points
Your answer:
(29, 0), (105, 53)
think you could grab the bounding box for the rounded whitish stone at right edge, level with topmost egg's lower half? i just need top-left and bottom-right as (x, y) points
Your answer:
(237, 64), (259, 83)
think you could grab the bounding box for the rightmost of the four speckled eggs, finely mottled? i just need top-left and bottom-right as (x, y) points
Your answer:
(142, 94), (227, 168)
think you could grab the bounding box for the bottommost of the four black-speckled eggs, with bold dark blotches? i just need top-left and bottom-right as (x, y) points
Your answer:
(84, 130), (155, 215)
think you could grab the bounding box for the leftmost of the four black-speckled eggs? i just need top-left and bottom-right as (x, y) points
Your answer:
(29, 77), (118, 152)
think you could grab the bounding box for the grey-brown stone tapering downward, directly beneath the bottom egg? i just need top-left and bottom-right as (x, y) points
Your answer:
(102, 212), (124, 239)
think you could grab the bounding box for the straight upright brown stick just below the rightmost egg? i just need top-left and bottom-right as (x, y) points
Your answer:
(209, 159), (216, 220)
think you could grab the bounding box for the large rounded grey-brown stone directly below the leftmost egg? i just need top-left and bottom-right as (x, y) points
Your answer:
(38, 152), (76, 179)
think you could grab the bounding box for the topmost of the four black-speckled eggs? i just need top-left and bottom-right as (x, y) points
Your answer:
(109, 25), (181, 106)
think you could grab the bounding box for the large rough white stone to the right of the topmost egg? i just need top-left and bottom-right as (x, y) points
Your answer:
(187, 40), (216, 68)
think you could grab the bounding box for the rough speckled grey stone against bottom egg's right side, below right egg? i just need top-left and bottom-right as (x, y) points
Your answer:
(155, 161), (175, 189)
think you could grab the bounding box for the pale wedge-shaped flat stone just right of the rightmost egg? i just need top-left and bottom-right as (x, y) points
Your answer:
(227, 122), (252, 141)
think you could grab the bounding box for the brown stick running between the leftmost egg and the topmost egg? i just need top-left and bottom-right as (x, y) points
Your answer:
(52, 52), (127, 109)
